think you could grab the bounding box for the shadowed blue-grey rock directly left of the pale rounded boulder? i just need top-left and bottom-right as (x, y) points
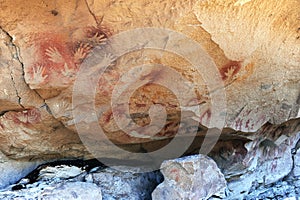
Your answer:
(85, 166), (162, 200)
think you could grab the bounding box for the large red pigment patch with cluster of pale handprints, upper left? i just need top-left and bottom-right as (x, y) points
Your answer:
(26, 24), (109, 87)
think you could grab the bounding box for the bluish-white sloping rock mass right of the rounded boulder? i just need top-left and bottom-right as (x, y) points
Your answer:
(209, 120), (300, 199)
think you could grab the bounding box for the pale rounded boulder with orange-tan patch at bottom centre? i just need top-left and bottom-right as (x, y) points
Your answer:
(152, 155), (226, 200)
